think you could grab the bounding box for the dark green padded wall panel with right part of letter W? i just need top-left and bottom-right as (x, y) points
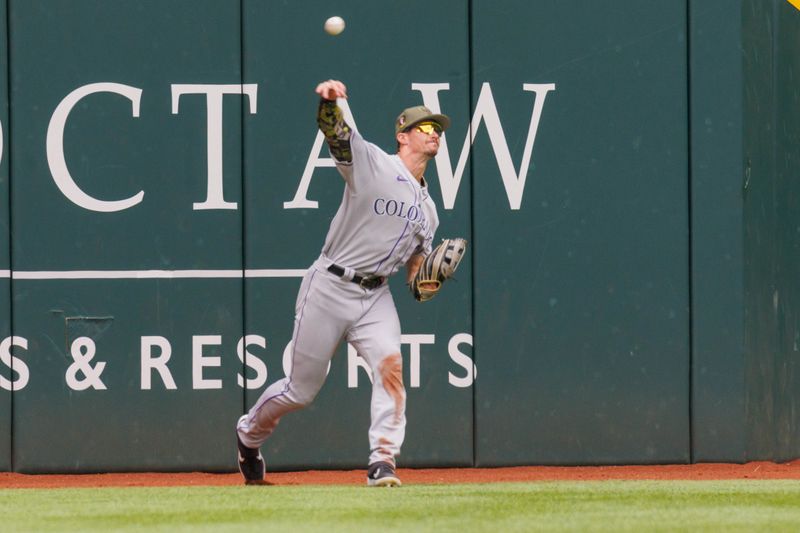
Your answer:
(472, 0), (689, 466)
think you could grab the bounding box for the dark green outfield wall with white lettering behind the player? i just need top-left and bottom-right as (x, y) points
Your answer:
(0, 0), (800, 473)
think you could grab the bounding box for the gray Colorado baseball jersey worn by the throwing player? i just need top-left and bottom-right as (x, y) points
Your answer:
(322, 131), (439, 276)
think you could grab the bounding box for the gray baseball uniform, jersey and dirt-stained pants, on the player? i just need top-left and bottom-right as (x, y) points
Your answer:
(237, 103), (439, 465)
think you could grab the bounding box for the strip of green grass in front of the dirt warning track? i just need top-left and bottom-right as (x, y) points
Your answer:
(0, 480), (800, 533)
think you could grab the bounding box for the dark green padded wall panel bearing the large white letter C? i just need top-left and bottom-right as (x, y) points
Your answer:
(10, 0), (243, 472)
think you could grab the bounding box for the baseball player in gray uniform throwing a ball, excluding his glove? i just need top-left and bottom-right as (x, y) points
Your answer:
(236, 80), (450, 486)
